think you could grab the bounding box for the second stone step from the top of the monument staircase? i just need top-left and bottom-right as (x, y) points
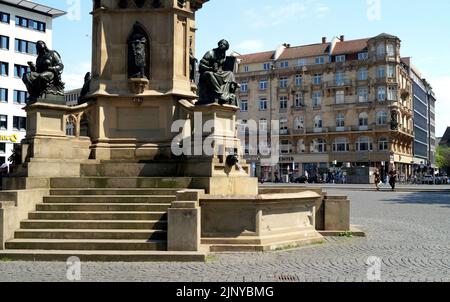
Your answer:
(50, 188), (183, 196)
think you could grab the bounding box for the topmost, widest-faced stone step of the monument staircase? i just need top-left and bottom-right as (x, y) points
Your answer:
(50, 177), (202, 189)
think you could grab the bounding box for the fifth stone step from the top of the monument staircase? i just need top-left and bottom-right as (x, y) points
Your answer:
(28, 211), (167, 220)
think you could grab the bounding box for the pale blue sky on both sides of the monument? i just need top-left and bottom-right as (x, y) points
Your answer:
(40, 0), (450, 137)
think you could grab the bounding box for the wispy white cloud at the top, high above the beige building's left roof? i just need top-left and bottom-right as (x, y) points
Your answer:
(244, 0), (330, 29)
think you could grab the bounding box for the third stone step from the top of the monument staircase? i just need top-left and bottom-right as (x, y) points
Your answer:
(44, 195), (177, 203)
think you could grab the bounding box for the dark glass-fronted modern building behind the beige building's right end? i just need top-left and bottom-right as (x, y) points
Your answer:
(402, 58), (436, 174)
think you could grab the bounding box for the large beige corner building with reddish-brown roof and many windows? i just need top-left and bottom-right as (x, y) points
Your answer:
(237, 34), (414, 181)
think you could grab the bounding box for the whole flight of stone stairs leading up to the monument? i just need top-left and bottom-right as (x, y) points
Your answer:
(0, 177), (205, 261)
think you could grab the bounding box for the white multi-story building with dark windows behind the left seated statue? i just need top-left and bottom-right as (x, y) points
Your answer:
(0, 0), (65, 164)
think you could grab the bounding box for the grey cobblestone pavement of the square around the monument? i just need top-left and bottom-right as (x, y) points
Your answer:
(0, 190), (450, 282)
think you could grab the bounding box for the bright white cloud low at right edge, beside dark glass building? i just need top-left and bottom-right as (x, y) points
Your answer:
(430, 76), (450, 137)
